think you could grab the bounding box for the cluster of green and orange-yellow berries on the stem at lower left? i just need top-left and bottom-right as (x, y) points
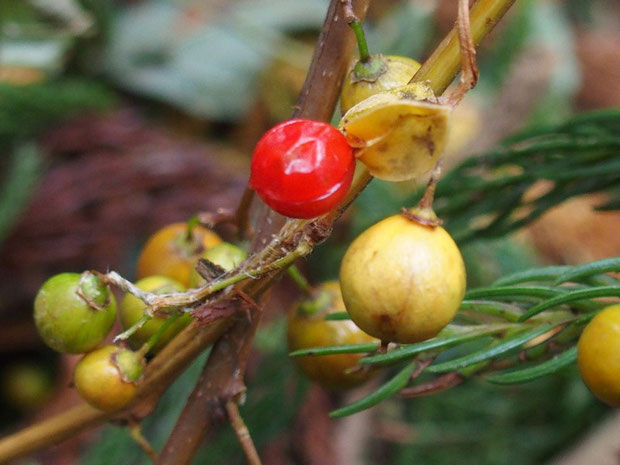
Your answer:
(34, 223), (246, 411)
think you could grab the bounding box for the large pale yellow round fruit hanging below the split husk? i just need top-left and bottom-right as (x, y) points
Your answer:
(340, 215), (465, 343)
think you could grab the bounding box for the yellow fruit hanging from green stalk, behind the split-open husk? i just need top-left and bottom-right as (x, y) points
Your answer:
(340, 55), (421, 113)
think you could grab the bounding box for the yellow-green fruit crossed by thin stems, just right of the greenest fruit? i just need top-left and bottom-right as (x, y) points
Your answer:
(120, 276), (193, 353)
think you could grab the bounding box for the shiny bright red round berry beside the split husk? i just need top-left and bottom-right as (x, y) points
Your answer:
(250, 119), (355, 218)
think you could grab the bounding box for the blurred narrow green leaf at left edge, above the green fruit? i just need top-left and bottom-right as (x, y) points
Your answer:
(0, 144), (41, 243)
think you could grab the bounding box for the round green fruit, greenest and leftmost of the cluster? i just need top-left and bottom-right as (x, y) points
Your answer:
(34, 272), (116, 354)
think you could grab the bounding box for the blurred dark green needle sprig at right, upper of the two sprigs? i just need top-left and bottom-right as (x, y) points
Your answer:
(428, 109), (620, 243)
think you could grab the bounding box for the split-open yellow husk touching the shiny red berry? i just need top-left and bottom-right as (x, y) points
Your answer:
(339, 83), (452, 181)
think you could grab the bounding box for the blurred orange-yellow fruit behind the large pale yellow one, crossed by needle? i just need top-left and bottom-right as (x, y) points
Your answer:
(287, 281), (379, 390)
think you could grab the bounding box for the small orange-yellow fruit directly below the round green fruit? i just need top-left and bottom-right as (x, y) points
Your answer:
(73, 345), (144, 412)
